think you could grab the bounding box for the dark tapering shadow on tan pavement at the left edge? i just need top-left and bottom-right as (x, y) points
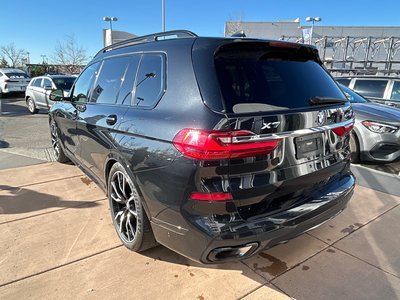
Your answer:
(0, 185), (99, 215)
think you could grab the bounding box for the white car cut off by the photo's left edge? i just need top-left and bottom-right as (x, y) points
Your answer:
(0, 68), (31, 96)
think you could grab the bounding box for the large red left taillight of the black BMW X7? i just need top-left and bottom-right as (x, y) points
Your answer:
(173, 128), (281, 160)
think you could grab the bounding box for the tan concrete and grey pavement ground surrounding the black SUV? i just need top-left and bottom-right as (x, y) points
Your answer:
(0, 99), (400, 300)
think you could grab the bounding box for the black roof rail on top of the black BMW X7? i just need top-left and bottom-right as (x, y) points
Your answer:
(94, 30), (197, 57)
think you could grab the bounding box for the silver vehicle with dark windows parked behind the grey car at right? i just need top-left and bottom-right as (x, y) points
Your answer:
(336, 76), (400, 108)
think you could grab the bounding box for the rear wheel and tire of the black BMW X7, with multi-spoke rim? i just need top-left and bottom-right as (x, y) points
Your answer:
(107, 162), (157, 252)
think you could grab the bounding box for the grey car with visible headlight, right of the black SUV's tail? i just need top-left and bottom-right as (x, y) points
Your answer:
(339, 84), (400, 163)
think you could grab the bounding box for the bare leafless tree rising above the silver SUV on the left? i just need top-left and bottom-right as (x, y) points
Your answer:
(52, 35), (88, 74)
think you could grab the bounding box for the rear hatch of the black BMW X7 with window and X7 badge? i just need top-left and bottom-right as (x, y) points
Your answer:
(193, 39), (353, 220)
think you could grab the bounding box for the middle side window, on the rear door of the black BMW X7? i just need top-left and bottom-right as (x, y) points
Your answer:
(90, 56), (129, 104)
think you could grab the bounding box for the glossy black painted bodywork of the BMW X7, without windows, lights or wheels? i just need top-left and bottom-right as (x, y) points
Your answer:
(50, 34), (354, 263)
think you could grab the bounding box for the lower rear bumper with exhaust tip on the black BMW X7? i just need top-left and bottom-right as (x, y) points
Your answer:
(153, 173), (355, 264)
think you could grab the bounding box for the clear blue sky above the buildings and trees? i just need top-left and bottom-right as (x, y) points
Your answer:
(0, 0), (400, 63)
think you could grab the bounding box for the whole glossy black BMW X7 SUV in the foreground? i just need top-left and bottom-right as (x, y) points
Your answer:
(49, 31), (355, 263)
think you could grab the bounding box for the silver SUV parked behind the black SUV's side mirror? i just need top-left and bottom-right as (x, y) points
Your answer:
(25, 75), (76, 114)
